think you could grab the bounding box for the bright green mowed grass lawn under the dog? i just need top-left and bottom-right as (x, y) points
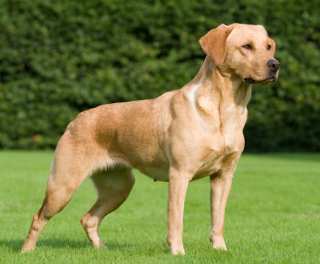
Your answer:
(0, 152), (320, 264)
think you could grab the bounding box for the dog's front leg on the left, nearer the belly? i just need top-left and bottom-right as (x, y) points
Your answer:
(168, 168), (190, 255)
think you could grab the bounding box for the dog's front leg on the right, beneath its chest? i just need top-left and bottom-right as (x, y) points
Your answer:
(210, 170), (233, 250)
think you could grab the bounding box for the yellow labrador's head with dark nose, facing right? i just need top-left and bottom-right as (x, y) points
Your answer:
(199, 24), (280, 83)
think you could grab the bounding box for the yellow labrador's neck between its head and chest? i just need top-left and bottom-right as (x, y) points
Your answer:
(185, 56), (251, 114)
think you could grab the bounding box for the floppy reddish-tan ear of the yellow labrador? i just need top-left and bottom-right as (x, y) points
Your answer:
(199, 24), (233, 65)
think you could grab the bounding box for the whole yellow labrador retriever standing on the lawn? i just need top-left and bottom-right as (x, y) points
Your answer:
(22, 24), (279, 255)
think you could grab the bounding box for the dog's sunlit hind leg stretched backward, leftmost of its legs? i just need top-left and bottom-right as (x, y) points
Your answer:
(22, 135), (97, 252)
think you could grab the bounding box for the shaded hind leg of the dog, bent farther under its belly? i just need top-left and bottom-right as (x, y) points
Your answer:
(81, 167), (134, 248)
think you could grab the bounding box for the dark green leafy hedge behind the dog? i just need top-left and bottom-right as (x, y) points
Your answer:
(0, 0), (320, 151)
